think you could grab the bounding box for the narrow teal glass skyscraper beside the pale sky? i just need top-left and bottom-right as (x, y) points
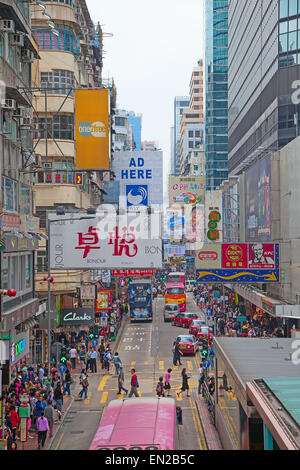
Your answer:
(205, 0), (229, 190)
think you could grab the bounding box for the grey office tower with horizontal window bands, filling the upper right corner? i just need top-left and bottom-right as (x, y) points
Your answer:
(228, 0), (300, 174)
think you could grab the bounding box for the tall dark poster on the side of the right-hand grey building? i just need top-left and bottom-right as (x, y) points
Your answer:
(245, 157), (271, 242)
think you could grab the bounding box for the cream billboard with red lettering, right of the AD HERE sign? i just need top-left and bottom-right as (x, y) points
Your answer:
(169, 176), (206, 206)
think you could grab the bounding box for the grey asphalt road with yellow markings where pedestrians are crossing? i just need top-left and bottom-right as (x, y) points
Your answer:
(51, 294), (207, 450)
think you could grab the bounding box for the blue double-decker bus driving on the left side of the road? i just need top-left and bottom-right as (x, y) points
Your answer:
(129, 279), (153, 322)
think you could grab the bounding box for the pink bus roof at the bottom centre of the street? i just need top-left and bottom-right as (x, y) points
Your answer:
(90, 397), (176, 450)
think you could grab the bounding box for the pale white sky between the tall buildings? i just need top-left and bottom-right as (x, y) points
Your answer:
(86, 0), (204, 191)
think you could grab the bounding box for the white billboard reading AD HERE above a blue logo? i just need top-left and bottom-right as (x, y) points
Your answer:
(112, 151), (163, 211)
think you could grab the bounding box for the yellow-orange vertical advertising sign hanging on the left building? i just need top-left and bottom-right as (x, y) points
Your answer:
(75, 88), (110, 170)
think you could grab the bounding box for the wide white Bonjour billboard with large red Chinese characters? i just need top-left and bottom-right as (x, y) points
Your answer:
(49, 213), (162, 270)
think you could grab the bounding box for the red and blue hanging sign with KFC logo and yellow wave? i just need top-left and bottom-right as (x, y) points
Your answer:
(196, 243), (280, 283)
